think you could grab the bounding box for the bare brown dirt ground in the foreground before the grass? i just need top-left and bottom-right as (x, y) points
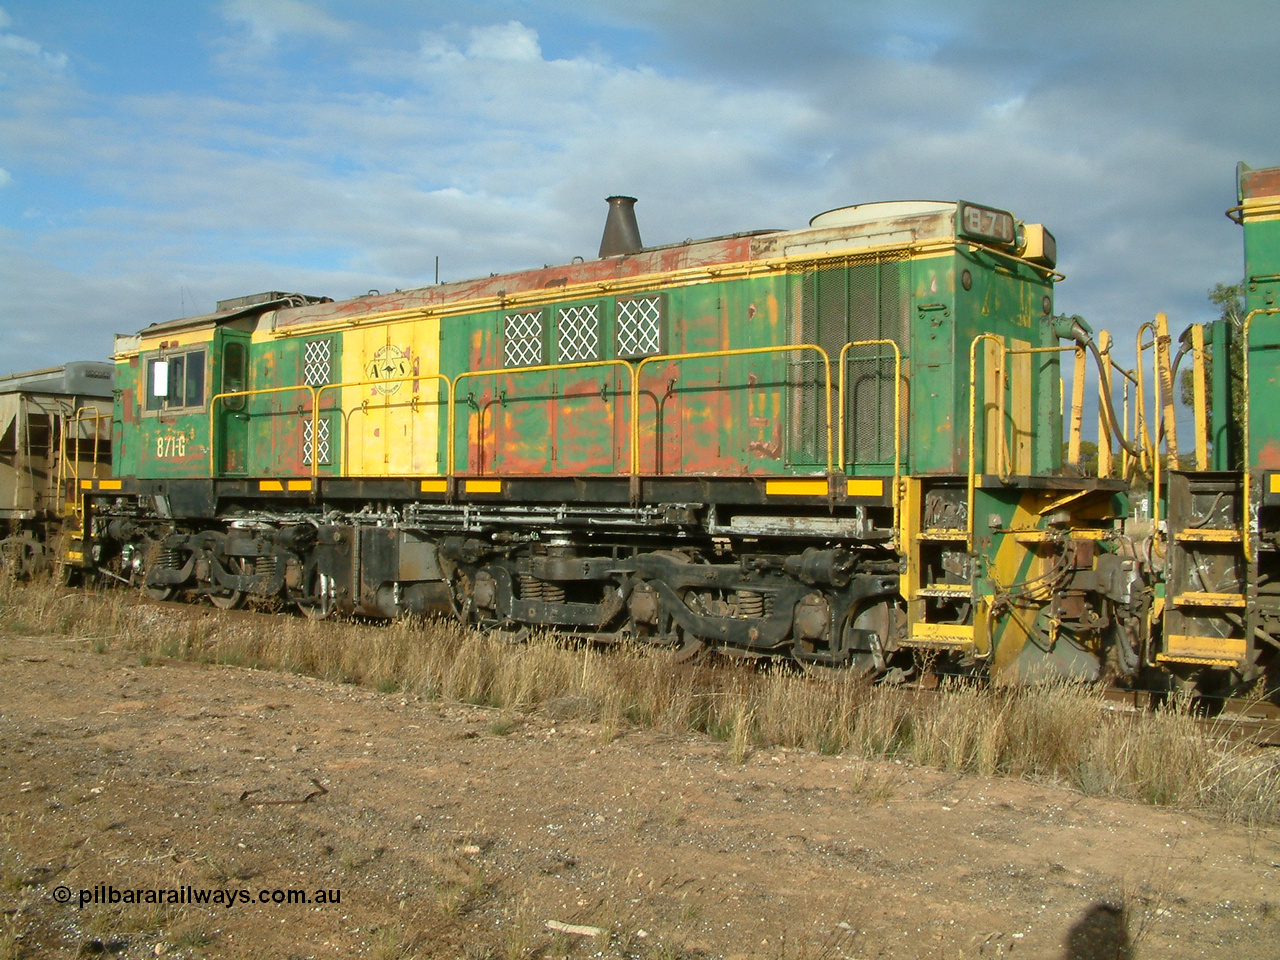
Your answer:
(0, 624), (1280, 960)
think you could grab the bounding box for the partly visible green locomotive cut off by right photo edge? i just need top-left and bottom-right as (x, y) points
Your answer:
(1155, 164), (1280, 691)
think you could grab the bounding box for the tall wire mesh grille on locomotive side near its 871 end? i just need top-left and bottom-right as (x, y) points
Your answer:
(790, 252), (908, 466)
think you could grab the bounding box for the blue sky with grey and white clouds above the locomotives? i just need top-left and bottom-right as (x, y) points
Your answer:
(0, 0), (1280, 374)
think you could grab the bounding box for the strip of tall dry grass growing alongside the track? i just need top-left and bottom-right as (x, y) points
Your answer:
(0, 570), (1280, 823)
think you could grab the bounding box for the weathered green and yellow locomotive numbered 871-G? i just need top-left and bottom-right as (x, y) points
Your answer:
(73, 197), (1149, 677)
